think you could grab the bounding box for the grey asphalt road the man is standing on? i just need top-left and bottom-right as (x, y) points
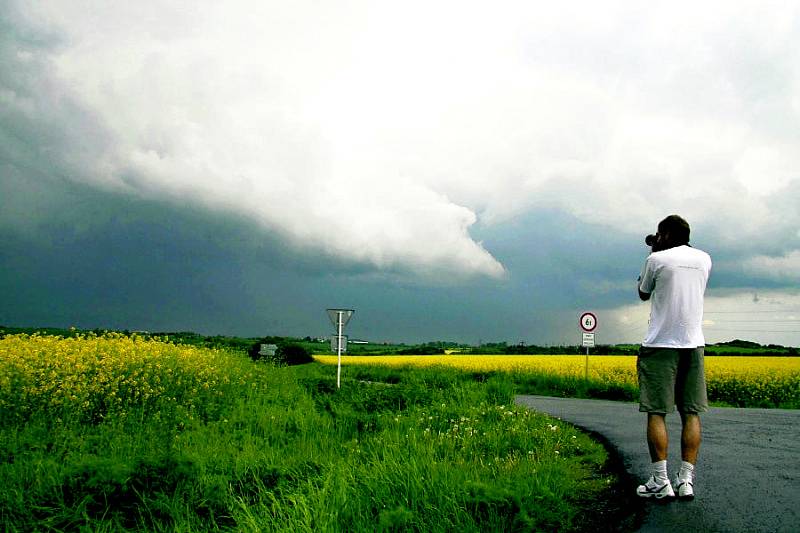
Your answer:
(517, 396), (800, 533)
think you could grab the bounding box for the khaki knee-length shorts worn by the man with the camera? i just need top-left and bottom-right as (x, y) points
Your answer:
(636, 346), (708, 414)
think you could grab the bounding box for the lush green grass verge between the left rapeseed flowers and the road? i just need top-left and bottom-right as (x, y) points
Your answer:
(0, 354), (632, 532)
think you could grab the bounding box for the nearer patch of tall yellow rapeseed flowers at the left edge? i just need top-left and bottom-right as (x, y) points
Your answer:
(0, 333), (253, 421)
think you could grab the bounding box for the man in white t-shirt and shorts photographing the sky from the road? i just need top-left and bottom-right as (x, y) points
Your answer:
(636, 215), (711, 499)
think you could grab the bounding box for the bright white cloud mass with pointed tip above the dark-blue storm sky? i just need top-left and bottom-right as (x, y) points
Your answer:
(10, 1), (800, 277)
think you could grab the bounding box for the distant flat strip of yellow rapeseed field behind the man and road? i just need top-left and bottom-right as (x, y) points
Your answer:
(315, 354), (800, 406)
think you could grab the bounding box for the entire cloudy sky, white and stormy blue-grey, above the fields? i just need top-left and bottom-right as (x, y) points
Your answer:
(0, 1), (800, 344)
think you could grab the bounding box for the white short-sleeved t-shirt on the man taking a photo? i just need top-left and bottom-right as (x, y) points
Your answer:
(639, 245), (711, 348)
